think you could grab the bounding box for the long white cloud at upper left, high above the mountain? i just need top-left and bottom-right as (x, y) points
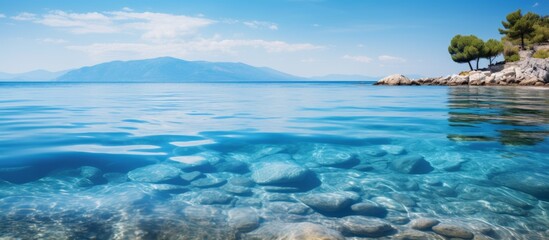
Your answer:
(19, 9), (215, 39)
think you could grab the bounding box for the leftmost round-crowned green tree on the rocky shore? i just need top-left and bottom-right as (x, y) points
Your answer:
(448, 35), (484, 71)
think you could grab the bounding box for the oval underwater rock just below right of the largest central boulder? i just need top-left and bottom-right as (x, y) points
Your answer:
(299, 192), (356, 213)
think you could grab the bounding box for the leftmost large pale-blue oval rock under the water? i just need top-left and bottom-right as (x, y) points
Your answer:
(128, 164), (181, 183)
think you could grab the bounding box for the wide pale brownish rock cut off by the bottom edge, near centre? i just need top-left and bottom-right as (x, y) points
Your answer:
(244, 222), (345, 240)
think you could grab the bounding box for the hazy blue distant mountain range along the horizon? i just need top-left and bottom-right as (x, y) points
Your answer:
(0, 57), (388, 82)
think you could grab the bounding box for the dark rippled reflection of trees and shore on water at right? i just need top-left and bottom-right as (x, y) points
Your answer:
(448, 87), (549, 145)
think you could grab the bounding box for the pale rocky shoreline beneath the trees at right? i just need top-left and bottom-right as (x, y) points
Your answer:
(374, 58), (549, 87)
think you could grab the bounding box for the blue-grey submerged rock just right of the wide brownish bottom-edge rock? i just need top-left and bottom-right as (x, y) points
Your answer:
(339, 216), (395, 237)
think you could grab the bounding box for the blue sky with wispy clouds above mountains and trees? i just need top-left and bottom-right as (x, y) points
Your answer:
(0, 0), (549, 76)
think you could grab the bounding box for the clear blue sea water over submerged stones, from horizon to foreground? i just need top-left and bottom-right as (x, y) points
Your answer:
(0, 83), (549, 239)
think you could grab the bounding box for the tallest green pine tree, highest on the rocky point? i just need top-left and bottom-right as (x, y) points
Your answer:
(499, 9), (540, 49)
